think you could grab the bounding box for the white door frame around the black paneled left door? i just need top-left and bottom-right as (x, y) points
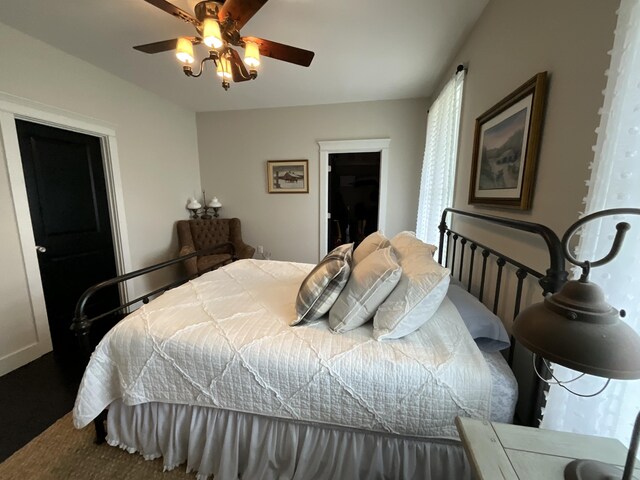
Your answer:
(0, 92), (131, 375)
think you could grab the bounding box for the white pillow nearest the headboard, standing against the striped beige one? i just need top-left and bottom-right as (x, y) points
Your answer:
(373, 232), (450, 340)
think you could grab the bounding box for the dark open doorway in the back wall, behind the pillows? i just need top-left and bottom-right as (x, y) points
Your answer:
(327, 152), (380, 251)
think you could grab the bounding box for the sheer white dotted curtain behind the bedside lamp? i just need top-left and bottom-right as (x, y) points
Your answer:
(542, 0), (640, 445)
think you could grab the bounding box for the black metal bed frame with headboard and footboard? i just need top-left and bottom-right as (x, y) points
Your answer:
(71, 208), (567, 443)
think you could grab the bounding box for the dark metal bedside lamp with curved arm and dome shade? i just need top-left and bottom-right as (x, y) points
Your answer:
(513, 208), (640, 480)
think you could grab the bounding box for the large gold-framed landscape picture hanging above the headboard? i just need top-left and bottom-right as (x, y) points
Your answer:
(469, 72), (547, 210)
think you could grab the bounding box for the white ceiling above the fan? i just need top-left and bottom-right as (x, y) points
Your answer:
(0, 0), (488, 111)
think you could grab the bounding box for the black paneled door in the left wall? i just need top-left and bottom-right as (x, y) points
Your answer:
(16, 120), (119, 358)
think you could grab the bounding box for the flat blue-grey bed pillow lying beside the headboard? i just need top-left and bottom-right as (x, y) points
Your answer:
(447, 279), (511, 352)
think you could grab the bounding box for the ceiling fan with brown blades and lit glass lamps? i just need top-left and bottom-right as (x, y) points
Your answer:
(133, 0), (314, 90)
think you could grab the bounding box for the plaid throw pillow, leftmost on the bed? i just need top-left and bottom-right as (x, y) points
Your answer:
(290, 243), (353, 325)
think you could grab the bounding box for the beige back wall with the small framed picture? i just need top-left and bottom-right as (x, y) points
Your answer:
(197, 99), (428, 263)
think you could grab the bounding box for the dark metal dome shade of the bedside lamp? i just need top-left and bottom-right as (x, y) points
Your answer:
(513, 280), (640, 380)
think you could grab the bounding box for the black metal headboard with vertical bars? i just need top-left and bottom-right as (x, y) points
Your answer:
(438, 208), (567, 426)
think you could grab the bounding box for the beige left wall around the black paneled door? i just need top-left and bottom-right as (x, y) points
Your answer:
(0, 23), (200, 372)
